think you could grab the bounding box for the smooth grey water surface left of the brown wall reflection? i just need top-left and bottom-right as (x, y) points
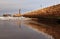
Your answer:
(0, 20), (52, 39)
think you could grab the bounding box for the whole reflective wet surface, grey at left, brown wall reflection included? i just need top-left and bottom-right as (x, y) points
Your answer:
(0, 19), (60, 39)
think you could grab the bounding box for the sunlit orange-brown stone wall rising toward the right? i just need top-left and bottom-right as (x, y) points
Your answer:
(23, 4), (60, 19)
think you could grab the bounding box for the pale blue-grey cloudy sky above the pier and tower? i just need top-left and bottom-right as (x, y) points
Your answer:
(0, 0), (60, 14)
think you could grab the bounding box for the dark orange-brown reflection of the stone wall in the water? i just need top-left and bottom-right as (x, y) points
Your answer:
(24, 20), (60, 39)
